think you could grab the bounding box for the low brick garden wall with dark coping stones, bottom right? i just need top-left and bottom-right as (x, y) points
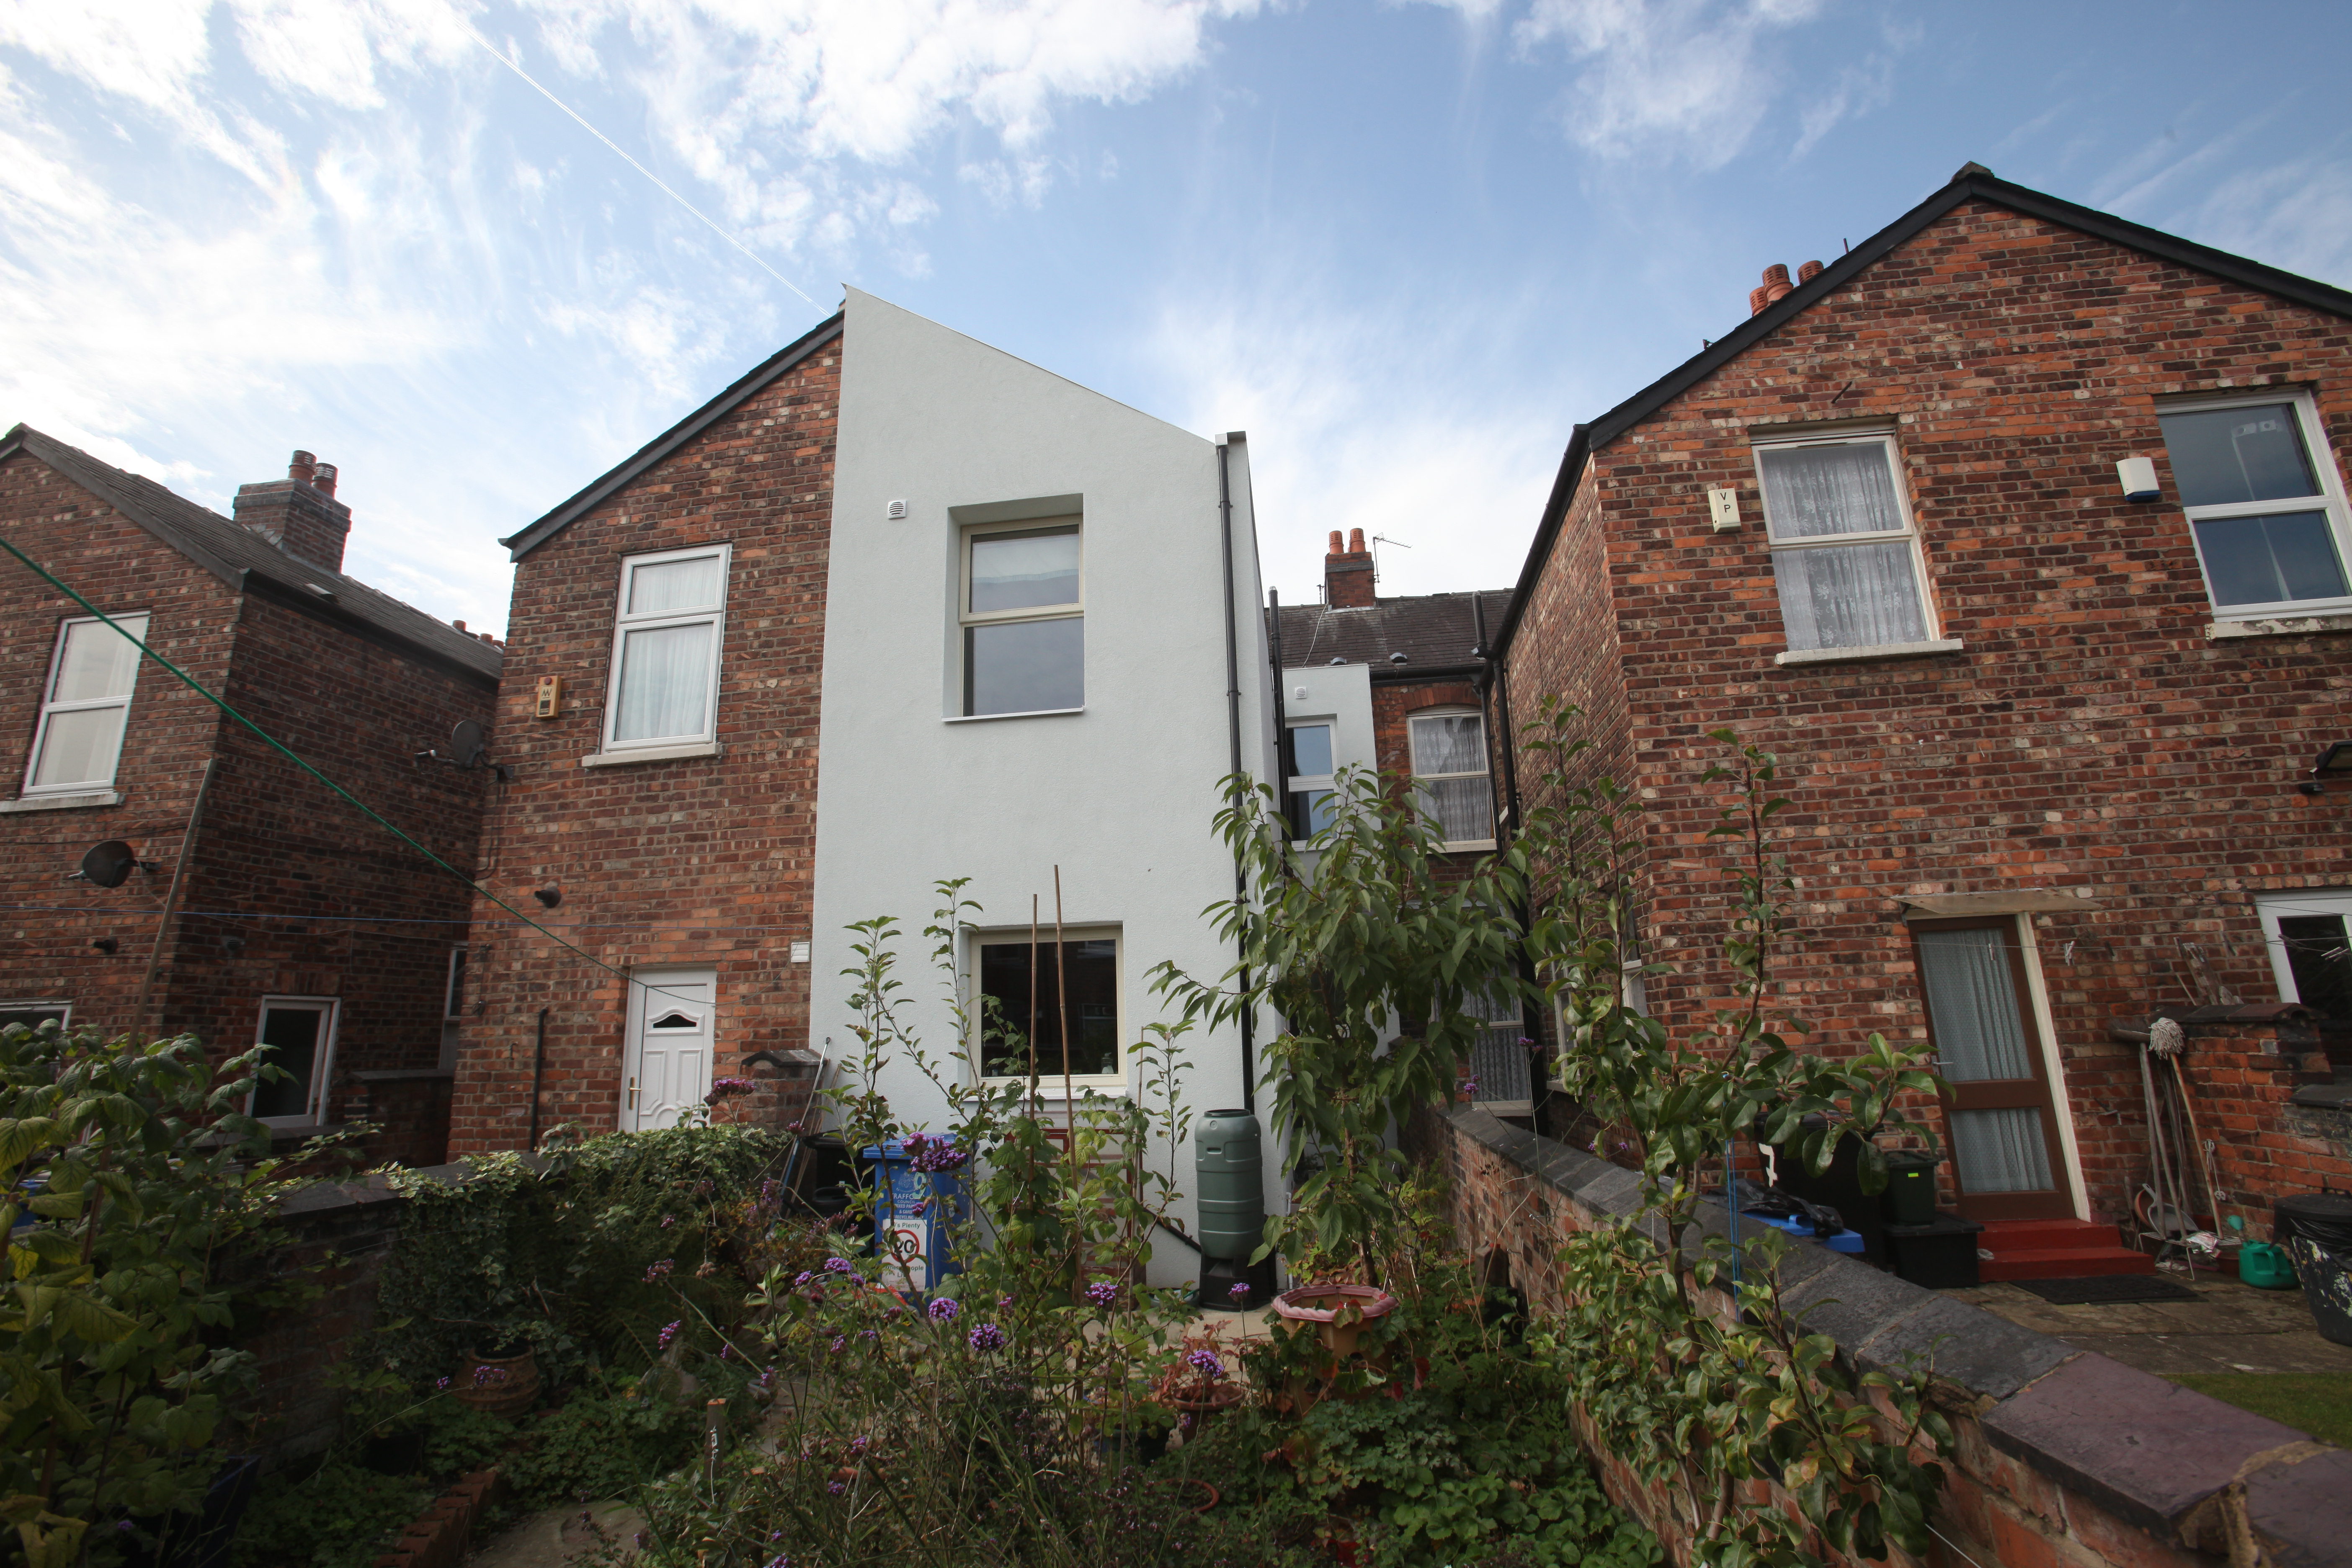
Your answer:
(1406, 1107), (2352, 1568)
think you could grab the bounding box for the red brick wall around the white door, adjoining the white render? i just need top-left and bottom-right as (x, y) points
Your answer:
(449, 341), (840, 1154)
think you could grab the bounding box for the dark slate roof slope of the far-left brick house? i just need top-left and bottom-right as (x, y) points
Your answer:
(0, 426), (505, 682)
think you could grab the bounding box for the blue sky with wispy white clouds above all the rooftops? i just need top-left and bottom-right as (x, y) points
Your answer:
(0, 0), (2352, 632)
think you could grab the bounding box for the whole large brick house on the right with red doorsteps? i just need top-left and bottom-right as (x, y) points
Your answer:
(1496, 165), (2352, 1277)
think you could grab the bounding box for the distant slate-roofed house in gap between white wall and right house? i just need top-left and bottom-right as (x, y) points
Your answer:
(1265, 541), (1531, 1114)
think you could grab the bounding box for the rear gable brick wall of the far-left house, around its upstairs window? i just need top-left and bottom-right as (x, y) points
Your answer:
(0, 451), (237, 1030)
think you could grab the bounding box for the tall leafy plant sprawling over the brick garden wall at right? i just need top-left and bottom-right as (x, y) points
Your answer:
(1524, 705), (1952, 1565)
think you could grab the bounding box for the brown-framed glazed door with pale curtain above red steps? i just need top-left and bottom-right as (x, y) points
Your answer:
(1912, 915), (2074, 1220)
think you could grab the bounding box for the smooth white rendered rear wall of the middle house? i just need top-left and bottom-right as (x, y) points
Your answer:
(809, 289), (1272, 1284)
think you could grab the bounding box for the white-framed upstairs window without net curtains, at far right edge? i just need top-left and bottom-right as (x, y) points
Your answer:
(2157, 392), (2352, 621)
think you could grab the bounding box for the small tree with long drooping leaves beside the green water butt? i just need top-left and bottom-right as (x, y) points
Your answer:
(1153, 769), (1522, 1279)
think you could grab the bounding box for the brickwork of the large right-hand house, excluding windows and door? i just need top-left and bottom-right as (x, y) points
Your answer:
(1508, 202), (2352, 1218)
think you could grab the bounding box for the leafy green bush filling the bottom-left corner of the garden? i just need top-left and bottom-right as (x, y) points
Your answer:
(0, 1023), (332, 1568)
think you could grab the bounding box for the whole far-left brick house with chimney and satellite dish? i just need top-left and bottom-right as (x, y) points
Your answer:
(0, 426), (501, 1164)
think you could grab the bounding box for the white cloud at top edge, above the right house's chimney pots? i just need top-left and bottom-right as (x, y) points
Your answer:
(1512, 0), (1828, 169)
